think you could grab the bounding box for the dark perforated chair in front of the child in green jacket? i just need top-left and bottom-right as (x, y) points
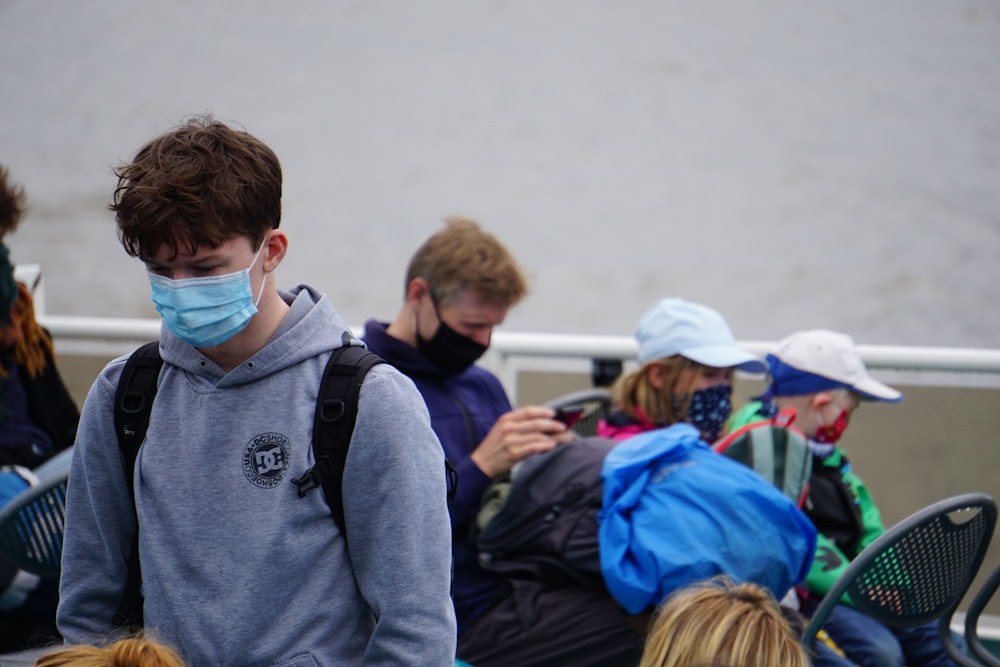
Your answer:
(802, 493), (997, 667)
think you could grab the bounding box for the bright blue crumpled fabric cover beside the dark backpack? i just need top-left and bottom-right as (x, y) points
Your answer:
(598, 423), (816, 614)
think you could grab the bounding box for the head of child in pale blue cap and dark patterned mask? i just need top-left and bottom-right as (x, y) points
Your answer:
(598, 298), (767, 442)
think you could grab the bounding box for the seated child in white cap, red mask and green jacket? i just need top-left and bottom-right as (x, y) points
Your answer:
(727, 329), (954, 667)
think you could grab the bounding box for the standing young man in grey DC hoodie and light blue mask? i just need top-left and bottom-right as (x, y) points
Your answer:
(58, 117), (456, 667)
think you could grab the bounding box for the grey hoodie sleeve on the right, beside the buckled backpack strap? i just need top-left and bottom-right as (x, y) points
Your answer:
(343, 365), (456, 666)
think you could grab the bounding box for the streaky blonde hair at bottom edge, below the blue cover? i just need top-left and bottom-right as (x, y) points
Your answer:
(640, 577), (809, 667)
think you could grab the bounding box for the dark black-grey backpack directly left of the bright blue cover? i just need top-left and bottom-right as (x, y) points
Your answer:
(470, 436), (617, 590)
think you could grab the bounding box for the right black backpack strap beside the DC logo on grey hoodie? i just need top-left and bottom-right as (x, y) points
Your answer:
(292, 341), (385, 540)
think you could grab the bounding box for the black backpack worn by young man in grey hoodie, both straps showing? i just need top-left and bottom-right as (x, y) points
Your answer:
(113, 337), (385, 629)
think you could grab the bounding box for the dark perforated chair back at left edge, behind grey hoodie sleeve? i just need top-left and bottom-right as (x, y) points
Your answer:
(0, 448), (73, 579)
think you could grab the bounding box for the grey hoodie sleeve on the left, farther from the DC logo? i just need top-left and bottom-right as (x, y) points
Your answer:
(56, 360), (136, 644)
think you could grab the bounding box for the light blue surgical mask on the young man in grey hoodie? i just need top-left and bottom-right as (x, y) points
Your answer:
(149, 244), (267, 347)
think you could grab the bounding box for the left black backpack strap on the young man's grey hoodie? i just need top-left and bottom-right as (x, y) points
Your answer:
(112, 342), (163, 629)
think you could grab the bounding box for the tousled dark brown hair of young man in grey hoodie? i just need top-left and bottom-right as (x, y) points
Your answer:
(108, 115), (281, 259)
